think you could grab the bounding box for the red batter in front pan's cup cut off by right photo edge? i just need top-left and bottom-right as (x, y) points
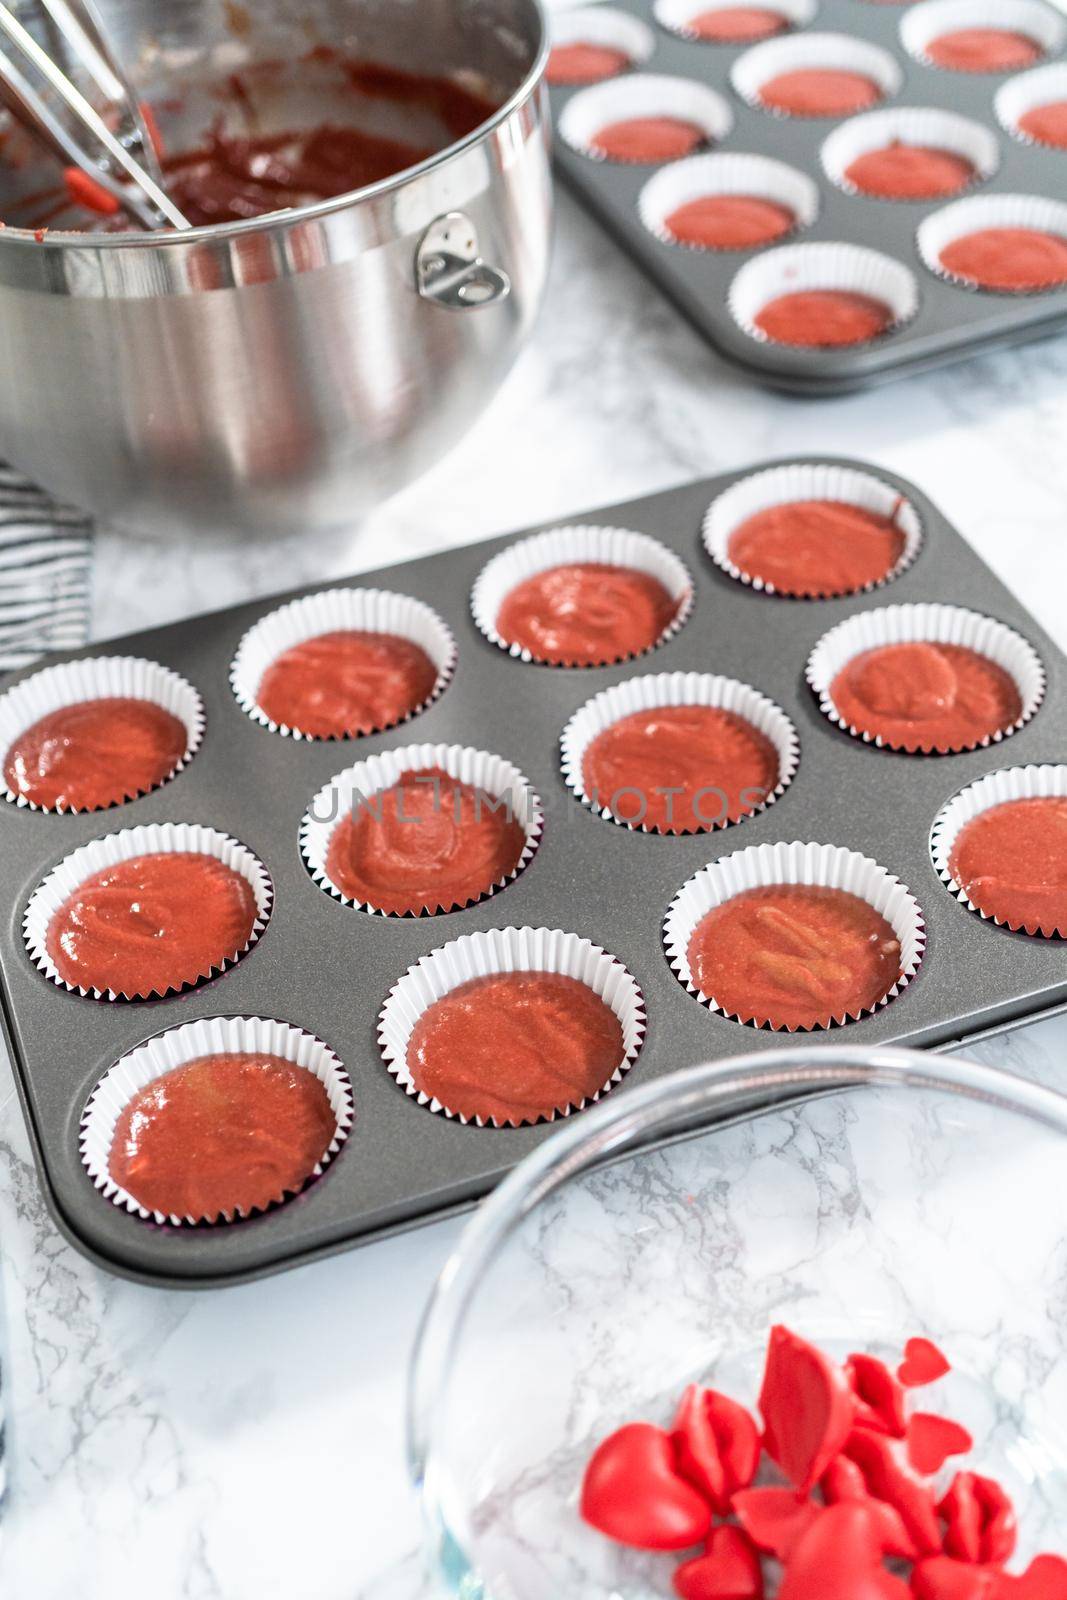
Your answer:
(949, 795), (1067, 938)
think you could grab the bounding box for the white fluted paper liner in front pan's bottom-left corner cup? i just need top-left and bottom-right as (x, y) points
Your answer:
(78, 1016), (354, 1227)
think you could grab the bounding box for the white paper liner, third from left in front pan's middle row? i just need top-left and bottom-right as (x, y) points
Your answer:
(560, 672), (800, 837)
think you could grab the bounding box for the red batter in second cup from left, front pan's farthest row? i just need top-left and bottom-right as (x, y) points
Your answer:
(256, 629), (437, 739)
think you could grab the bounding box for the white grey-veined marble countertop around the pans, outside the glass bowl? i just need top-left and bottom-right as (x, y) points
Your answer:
(0, 197), (1067, 1600)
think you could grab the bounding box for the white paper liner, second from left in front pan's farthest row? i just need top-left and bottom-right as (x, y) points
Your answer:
(230, 589), (456, 739)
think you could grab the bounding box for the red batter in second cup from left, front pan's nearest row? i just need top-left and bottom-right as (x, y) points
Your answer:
(408, 973), (625, 1128)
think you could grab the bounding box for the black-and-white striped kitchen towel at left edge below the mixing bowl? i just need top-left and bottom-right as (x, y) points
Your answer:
(0, 462), (93, 672)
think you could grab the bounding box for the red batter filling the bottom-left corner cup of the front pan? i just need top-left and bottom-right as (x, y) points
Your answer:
(107, 1053), (338, 1222)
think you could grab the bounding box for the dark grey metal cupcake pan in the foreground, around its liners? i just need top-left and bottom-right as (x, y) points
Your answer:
(0, 462), (1067, 1286)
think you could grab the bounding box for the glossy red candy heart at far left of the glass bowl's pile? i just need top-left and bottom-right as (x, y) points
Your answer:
(581, 1422), (712, 1550)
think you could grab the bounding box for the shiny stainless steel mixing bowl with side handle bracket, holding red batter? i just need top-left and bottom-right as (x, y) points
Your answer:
(0, 0), (552, 538)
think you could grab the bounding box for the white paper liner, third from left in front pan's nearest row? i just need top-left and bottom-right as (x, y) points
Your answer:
(664, 840), (926, 1032)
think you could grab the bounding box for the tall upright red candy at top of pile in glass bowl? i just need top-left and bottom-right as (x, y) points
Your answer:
(760, 1326), (856, 1494)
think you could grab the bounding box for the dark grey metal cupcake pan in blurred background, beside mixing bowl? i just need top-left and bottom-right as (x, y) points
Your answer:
(550, 0), (1067, 395)
